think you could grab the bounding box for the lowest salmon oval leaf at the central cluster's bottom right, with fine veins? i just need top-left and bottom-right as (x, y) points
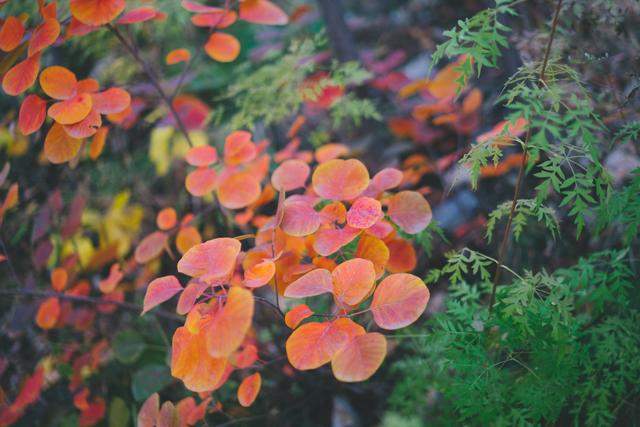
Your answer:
(331, 332), (387, 383)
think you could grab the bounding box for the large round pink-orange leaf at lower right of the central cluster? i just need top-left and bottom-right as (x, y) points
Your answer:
(371, 273), (429, 329)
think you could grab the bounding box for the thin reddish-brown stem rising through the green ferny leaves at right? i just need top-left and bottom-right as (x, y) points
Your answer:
(489, 0), (563, 314)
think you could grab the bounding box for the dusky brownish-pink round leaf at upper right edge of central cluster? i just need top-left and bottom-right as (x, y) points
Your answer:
(387, 191), (432, 234)
